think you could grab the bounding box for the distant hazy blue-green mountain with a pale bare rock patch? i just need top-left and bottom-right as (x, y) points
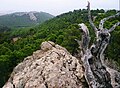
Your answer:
(0, 11), (54, 27)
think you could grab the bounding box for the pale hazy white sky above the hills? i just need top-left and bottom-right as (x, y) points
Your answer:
(0, 0), (120, 15)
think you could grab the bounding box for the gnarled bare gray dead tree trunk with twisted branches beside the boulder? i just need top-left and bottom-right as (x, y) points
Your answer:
(76, 2), (120, 88)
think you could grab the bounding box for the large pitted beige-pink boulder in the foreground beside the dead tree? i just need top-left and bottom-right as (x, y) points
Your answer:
(3, 41), (83, 88)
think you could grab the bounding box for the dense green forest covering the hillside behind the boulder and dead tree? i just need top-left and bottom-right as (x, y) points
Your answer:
(0, 9), (120, 87)
